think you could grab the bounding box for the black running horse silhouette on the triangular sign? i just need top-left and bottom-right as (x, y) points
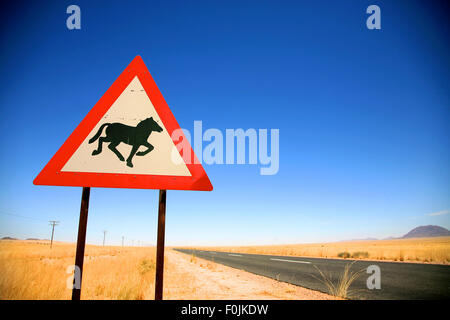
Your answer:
(89, 117), (163, 168)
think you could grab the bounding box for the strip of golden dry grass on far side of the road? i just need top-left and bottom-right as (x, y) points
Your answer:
(190, 237), (450, 264)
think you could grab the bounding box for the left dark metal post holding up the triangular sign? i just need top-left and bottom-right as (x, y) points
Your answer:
(72, 187), (91, 300)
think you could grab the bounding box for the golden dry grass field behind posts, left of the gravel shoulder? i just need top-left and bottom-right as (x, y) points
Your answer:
(0, 241), (155, 300)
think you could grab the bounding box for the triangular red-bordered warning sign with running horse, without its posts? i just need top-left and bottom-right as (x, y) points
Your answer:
(33, 56), (213, 191)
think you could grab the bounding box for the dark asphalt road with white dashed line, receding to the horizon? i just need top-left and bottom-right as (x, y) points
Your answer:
(175, 249), (450, 300)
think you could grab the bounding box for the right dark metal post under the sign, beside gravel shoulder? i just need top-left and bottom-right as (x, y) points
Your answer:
(155, 190), (166, 300)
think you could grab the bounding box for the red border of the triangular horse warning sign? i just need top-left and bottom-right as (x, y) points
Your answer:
(33, 56), (213, 191)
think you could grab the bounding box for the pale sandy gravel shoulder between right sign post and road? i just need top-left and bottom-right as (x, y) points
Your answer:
(164, 250), (336, 300)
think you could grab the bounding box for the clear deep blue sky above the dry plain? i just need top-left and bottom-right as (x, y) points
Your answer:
(0, 1), (450, 245)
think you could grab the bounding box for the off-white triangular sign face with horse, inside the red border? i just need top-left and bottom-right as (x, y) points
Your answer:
(61, 77), (191, 176)
